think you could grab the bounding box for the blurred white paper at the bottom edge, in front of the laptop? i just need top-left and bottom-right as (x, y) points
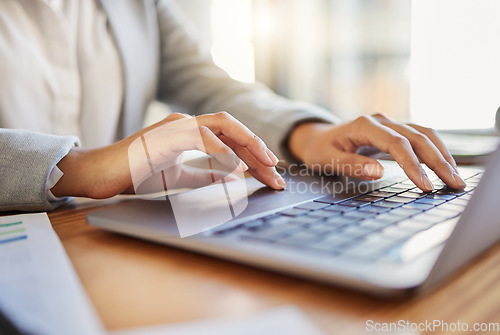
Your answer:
(110, 306), (321, 335)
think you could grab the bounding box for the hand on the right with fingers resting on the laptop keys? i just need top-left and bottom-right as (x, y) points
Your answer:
(288, 114), (465, 192)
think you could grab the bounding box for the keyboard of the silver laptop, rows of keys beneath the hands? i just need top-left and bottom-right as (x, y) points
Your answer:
(207, 173), (482, 262)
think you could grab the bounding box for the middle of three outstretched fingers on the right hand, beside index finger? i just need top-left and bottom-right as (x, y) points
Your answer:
(387, 123), (465, 189)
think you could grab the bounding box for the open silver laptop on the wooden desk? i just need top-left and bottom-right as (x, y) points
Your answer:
(87, 149), (500, 296)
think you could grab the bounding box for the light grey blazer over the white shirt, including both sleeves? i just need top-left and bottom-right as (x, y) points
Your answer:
(0, 0), (338, 211)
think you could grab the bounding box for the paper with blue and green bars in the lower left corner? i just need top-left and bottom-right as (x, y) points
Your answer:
(0, 213), (105, 335)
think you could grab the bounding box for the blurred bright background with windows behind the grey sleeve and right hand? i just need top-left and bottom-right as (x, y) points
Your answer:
(177, 0), (500, 133)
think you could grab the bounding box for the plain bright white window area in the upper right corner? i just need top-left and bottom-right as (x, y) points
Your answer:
(410, 0), (500, 129)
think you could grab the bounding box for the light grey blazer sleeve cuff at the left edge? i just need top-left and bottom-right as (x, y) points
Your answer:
(0, 129), (78, 211)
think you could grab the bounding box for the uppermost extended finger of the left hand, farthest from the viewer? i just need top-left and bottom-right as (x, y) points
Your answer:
(196, 112), (278, 166)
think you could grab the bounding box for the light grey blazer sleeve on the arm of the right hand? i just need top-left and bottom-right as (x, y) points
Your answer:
(156, 0), (340, 160)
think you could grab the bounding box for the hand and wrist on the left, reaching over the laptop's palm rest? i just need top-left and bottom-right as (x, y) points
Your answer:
(51, 112), (286, 199)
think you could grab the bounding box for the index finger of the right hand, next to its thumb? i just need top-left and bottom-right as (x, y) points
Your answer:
(352, 116), (433, 192)
